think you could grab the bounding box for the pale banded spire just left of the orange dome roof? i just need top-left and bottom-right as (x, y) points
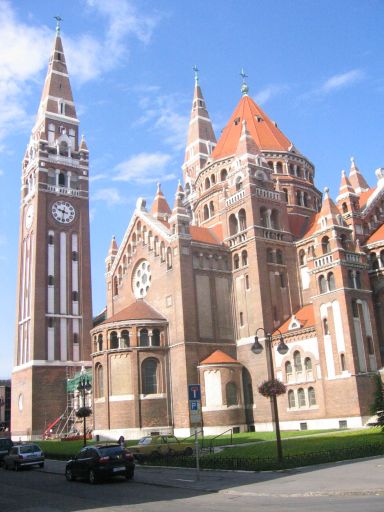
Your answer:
(183, 66), (216, 183)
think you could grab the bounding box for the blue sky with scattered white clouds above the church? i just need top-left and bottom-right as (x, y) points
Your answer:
(0, 0), (384, 378)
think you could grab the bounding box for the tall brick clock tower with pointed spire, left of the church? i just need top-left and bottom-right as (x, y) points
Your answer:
(11, 23), (92, 439)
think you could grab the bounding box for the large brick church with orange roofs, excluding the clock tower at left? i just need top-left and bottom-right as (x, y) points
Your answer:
(91, 71), (384, 438)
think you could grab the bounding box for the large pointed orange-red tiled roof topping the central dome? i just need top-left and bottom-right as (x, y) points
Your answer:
(212, 96), (292, 160)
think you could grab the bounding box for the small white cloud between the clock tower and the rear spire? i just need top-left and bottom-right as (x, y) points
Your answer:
(113, 152), (176, 183)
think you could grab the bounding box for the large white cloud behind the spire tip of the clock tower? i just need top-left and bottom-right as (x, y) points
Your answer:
(0, 0), (158, 148)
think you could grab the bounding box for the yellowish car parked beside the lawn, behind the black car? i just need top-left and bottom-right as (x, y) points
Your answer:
(129, 435), (193, 460)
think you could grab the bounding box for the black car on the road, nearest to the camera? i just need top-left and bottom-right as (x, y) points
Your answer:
(65, 444), (135, 484)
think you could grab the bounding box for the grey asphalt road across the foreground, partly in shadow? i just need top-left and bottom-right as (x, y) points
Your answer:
(0, 457), (384, 512)
